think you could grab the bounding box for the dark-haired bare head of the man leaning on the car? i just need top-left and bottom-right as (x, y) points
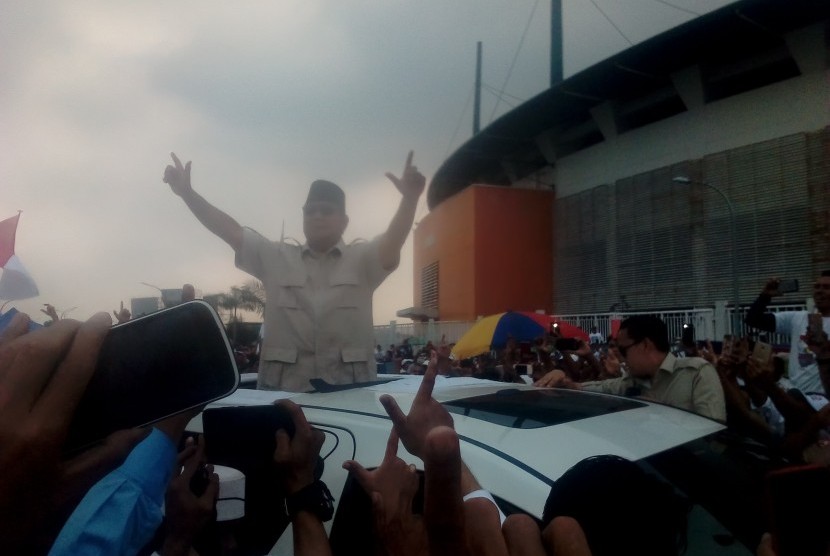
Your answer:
(617, 315), (671, 378)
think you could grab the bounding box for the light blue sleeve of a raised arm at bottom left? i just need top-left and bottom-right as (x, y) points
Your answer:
(49, 429), (177, 556)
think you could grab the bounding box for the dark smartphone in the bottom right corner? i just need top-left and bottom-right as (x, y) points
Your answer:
(765, 464), (830, 556)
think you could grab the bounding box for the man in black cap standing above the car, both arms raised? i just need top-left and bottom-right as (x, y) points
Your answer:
(164, 152), (426, 392)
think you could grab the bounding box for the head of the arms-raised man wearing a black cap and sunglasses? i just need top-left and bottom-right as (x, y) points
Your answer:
(303, 180), (349, 253)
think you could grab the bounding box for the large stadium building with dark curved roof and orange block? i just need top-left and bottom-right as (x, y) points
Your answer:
(414, 0), (830, 320)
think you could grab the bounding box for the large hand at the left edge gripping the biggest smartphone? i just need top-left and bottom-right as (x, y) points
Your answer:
(0, 313), (111, 553)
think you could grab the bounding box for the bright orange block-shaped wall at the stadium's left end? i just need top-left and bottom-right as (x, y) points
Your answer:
(413, 186), (553, 320)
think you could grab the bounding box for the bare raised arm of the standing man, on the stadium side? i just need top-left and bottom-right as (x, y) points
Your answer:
(380, 151), (426, 270)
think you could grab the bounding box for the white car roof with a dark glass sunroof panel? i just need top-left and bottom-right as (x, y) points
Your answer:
(198, 376), (725, 472)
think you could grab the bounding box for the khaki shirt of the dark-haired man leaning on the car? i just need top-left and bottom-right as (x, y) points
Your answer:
(581, 353), (726, 421)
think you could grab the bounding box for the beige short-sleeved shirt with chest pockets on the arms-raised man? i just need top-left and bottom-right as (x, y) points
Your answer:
(236, 228), (391, 392)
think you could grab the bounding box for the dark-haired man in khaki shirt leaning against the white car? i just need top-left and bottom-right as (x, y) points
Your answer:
(536, 315), (726, 421)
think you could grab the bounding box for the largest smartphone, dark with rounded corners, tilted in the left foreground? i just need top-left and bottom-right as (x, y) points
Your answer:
(64, 300), (239, 454)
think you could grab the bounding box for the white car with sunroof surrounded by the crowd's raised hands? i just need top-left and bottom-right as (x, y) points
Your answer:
(188, 377), (760, 555)
